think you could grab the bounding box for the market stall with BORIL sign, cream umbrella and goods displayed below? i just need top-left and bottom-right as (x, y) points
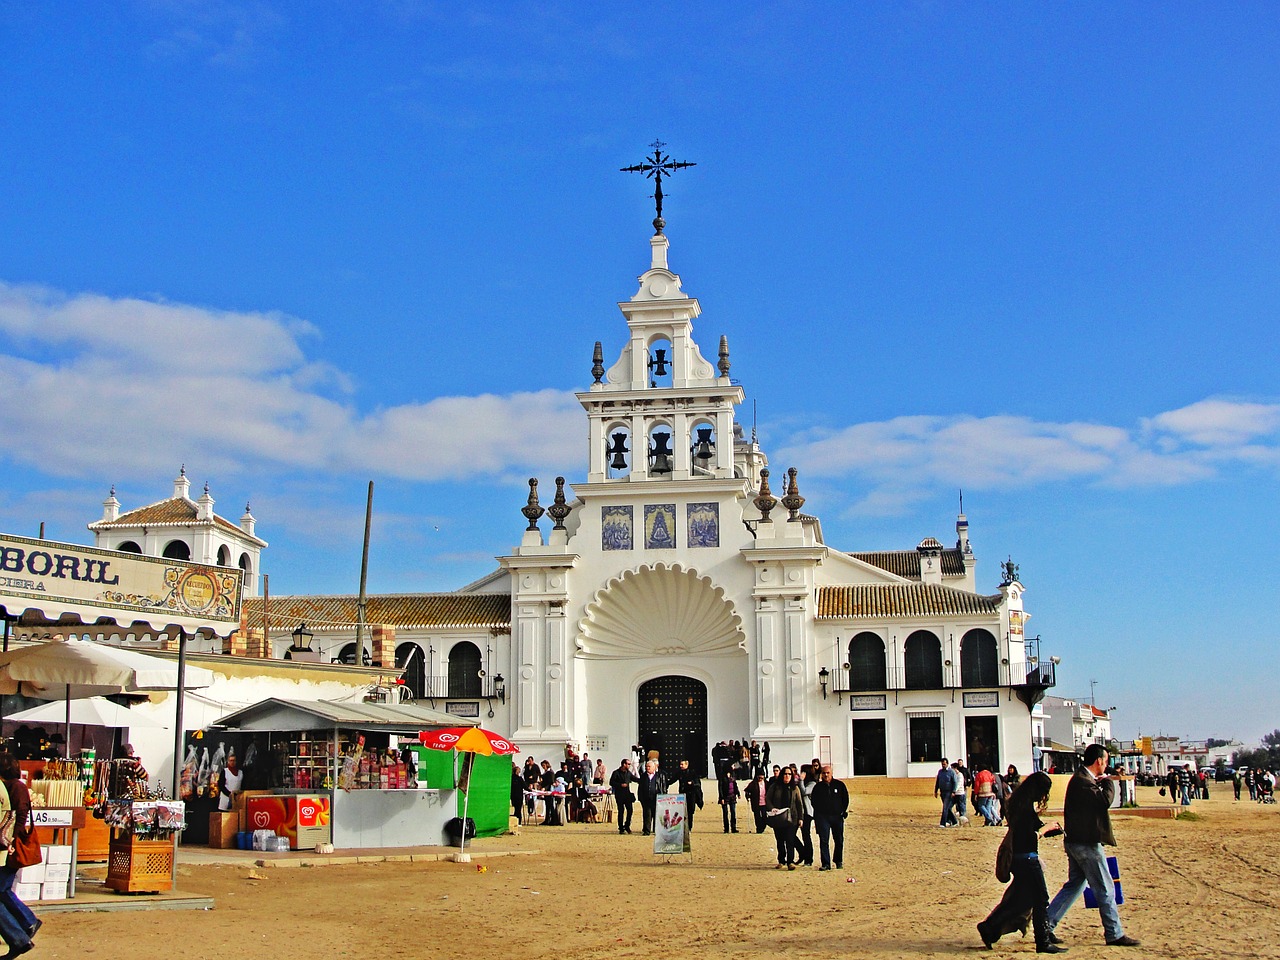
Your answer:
(0, 534), (242, 899)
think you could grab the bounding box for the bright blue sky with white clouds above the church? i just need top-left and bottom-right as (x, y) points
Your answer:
(0, 0), (1280, 740)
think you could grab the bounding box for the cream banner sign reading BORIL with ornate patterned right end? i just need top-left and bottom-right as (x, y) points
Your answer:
(0, 534), (241, 634)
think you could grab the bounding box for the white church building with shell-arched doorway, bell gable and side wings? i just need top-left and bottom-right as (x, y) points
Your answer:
(246, 225), (1053, 777)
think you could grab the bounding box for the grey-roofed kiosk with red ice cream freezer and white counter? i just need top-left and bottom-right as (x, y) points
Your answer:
(209, 698), (488, 850)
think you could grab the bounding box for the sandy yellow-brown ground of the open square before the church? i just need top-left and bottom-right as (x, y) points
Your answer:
(31, 783), (1280, 960)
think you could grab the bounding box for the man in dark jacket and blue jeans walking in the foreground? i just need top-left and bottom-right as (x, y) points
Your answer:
(1048, 744), (1138, 947)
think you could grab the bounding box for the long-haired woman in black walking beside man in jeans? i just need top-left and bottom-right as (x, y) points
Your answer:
(978, 773), (1066, 954)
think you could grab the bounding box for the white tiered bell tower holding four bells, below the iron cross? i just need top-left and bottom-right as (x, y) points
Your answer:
(577, 233), (742, 484)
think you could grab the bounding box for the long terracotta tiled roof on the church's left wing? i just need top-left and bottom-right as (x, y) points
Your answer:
(241, 594), (511, 627)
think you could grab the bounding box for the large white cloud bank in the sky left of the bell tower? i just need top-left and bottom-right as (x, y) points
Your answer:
(0, 284), (581, 480)
